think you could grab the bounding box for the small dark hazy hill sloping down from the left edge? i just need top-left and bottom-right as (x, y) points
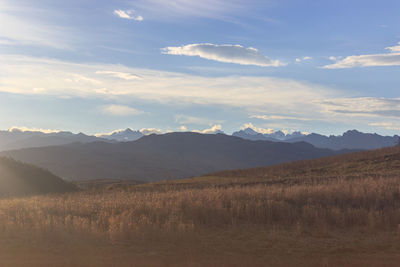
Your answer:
(0, 157), (77, 197)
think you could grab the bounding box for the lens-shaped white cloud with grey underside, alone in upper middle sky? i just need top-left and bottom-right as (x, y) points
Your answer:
(162, 43), (285, 67)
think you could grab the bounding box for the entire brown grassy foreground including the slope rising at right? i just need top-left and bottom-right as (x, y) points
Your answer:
(0, 147), (400, 266)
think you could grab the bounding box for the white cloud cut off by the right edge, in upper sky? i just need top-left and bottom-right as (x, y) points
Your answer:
(323, 43), (400, 69)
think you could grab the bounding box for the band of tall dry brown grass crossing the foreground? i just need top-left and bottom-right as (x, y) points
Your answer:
(0, 175), (400, 244)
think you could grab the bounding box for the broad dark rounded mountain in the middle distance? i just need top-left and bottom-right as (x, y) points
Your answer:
(2, 133), (354, 181)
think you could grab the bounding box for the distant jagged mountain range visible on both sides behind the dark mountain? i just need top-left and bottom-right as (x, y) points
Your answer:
(0, 128), (399, 151)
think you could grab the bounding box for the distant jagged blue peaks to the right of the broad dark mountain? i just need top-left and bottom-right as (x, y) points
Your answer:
(233, 129), (399, 150)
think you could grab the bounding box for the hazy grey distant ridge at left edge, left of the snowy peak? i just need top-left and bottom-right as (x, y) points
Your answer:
(0, 130), (110, 151)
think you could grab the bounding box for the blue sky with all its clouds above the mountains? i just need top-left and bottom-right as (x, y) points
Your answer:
(0, 0), (400, 135)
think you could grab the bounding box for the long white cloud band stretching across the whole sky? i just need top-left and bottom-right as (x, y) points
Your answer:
(0, 55), (400, 129)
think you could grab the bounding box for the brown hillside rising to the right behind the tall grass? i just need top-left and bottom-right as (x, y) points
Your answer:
(145, 146), (400, 191)
